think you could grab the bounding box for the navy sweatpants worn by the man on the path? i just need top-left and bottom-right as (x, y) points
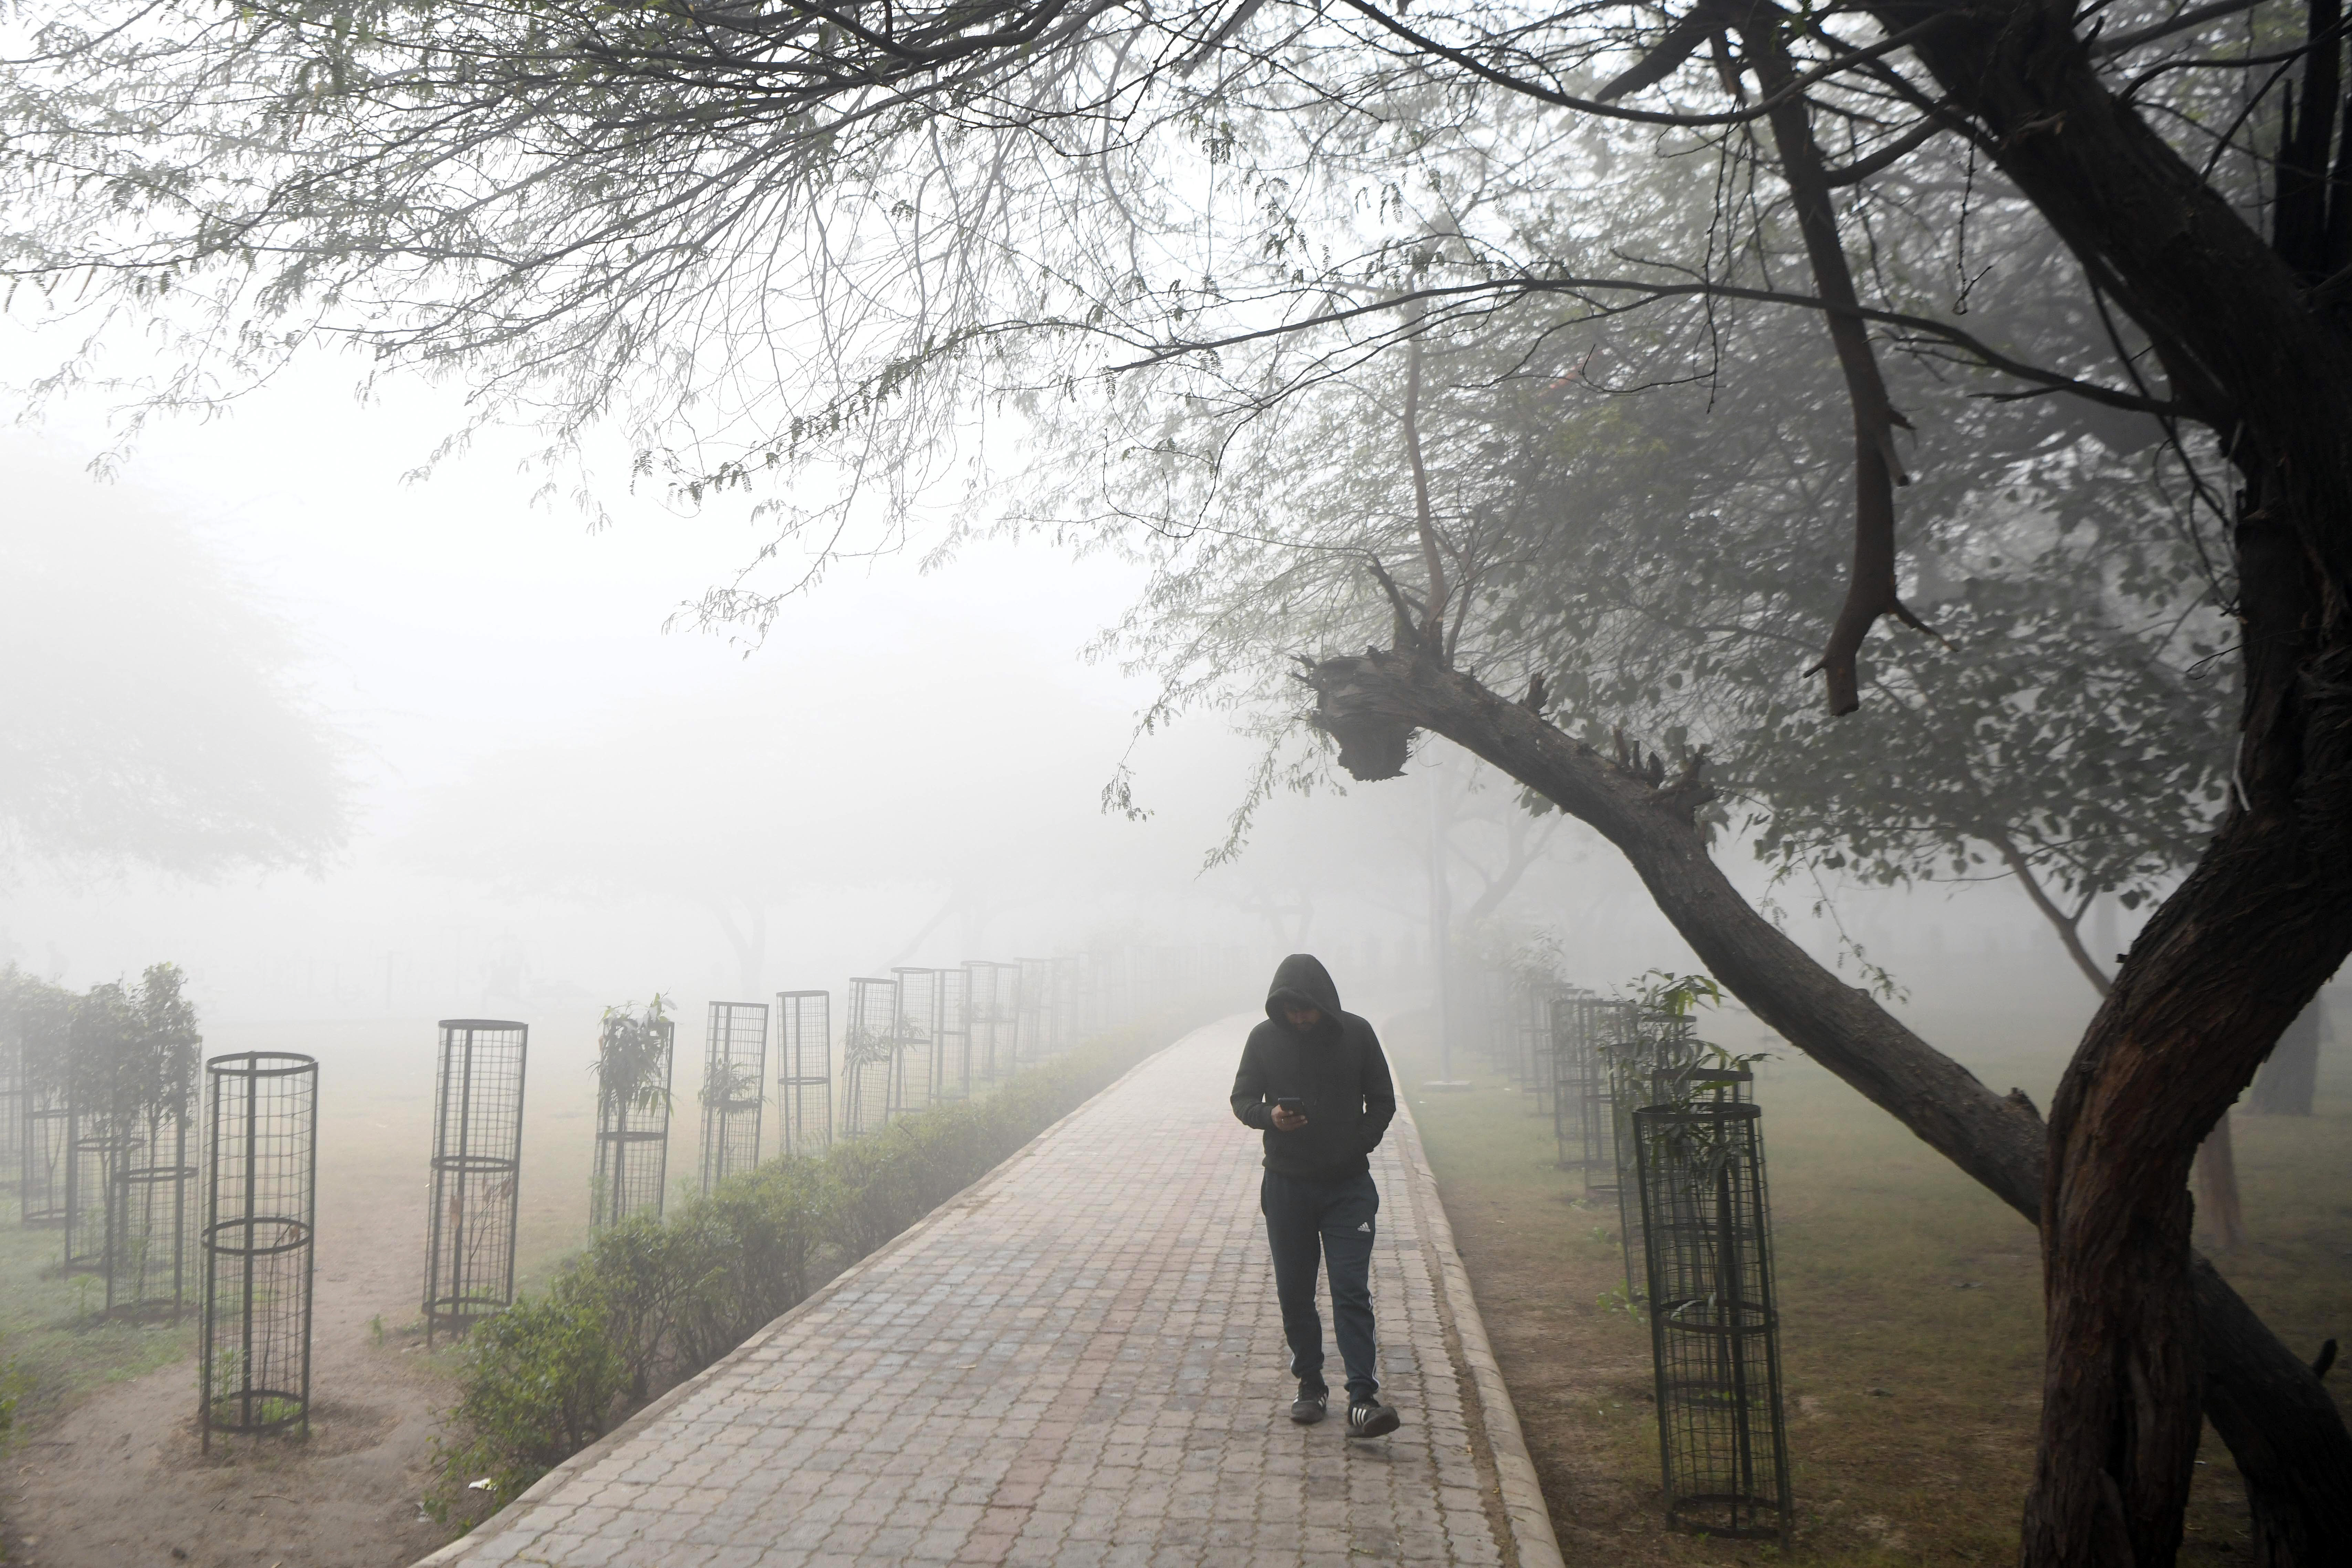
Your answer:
(1258, 1171), (1381, 1403)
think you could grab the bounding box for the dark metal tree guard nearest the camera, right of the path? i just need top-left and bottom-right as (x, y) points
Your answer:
(1632, 1100), (1790, 1545)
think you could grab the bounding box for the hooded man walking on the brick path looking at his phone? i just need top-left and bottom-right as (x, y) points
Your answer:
(1232, 952), (1397, 1437)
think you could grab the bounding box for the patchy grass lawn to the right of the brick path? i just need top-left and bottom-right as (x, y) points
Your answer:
(1388, 1015), (2352, 1566)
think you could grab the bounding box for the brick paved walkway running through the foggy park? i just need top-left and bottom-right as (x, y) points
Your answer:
(428, 1018), (1559, 1568)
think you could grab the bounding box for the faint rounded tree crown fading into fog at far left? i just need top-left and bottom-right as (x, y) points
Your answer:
(0, 461), (351, 877)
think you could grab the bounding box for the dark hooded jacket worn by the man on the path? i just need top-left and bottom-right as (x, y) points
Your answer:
(1232, 952), (1397, 1180)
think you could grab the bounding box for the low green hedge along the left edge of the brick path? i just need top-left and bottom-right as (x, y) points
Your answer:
(433, 1032), (1146, 1519)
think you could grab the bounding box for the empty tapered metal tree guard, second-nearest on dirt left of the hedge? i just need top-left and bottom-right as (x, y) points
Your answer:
(424, 1018), (532, 1347)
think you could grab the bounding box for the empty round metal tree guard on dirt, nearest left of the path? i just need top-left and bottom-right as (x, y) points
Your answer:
(198, 1051), (317, 1448)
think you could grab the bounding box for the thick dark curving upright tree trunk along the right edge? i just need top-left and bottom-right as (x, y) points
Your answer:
(1834, 0), (2352, 1568)
